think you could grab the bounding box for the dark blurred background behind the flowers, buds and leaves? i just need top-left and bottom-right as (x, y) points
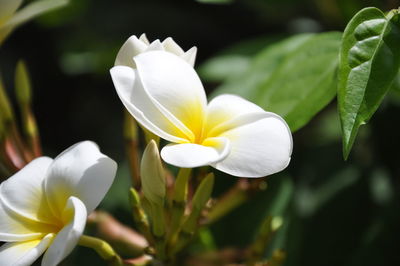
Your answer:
(0, 0), (400, 266)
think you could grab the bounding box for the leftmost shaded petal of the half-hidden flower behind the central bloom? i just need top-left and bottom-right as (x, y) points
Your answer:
(114, 35), (148, 68)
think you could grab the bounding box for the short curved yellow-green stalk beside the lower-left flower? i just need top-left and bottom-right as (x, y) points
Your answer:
(79, 235), (124, 266)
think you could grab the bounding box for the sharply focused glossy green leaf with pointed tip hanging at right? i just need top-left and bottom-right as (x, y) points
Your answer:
(338, 8), (400, 159)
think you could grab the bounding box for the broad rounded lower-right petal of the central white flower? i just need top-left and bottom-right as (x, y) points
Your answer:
(211, 112), (292, 177)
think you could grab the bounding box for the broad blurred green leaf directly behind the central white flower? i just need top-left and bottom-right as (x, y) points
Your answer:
(214, 32), (341, 131)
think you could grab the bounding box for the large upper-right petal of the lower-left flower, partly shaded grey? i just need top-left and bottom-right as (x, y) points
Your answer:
(45, 141), (117, 217)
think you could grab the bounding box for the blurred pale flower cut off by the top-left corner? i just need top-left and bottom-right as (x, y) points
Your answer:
(0, 0), (68, 43)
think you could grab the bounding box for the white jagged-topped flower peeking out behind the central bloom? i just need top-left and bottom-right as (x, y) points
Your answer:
(115, 33), (197, 68)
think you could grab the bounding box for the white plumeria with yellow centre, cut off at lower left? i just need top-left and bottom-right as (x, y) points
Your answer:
(0, 141), (117, 266)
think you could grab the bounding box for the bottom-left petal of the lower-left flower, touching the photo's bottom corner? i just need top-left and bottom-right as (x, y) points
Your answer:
(0, 234), (54, 266)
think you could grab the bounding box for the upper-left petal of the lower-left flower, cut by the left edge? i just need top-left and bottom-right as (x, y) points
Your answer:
(0, 157), (54, 223)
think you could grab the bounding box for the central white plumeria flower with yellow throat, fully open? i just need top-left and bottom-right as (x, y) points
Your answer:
(111, 35), (292, 177)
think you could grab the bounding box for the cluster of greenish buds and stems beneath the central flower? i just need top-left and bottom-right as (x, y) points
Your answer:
(125, 117), (285, 265)
